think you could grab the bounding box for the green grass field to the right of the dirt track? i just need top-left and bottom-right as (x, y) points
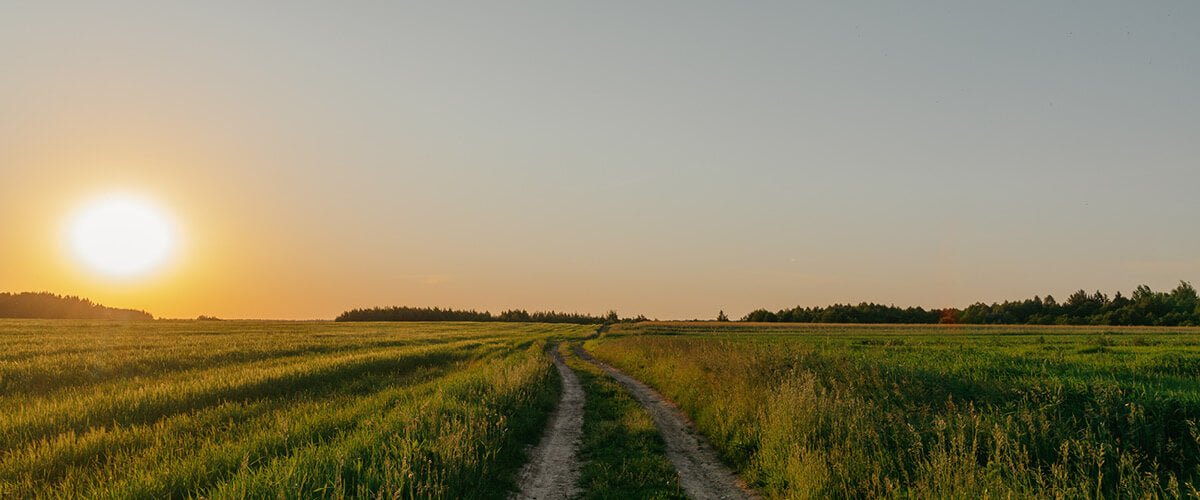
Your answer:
(588, 324), (1200, 498)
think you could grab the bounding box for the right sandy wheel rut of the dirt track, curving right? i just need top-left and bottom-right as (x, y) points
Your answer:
(575, 347), (760, 500)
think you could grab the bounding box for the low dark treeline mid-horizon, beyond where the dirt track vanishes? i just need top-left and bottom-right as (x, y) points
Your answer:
(334, 306), (646, 325)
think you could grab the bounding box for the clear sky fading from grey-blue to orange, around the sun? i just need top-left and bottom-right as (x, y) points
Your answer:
(0, 1), (1200, 319)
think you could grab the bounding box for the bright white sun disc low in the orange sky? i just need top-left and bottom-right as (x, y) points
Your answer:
(67, 195), (174, 277)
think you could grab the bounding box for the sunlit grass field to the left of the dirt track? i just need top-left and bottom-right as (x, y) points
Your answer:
(0, 321), (592, 498)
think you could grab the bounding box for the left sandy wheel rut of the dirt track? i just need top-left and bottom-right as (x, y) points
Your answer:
(512, 345), (584, 500)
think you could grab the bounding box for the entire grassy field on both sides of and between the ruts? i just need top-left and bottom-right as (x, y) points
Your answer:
(9, 320), (1200, 499)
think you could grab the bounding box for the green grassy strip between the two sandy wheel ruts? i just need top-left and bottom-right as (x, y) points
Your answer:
(559, 343), (688, 499)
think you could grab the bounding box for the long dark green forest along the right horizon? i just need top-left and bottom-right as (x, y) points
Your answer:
(742, 282), (1200, 326)
